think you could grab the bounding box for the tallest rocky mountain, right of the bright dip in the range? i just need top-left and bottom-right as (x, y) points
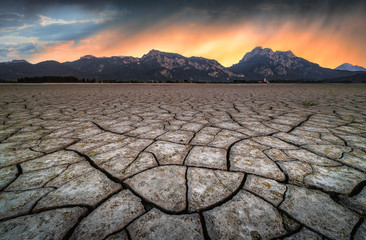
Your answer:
(229, 47), (353, 80)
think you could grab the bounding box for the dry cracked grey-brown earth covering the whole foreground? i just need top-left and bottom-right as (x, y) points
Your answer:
(0, 84), (366, 240)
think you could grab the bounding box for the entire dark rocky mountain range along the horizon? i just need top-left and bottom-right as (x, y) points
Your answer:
(0, 47), (366, 82)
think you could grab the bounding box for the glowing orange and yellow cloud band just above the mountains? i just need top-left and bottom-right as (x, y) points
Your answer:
(31, 15), (366, 68)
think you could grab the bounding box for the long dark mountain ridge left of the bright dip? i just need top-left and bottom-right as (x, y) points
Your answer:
(0, 50), (244, 82)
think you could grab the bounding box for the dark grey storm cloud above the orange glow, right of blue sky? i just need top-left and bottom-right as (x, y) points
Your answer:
(77, 0), (366, 37)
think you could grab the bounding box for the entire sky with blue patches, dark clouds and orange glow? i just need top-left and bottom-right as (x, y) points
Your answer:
(0, 0), (366, 68)
